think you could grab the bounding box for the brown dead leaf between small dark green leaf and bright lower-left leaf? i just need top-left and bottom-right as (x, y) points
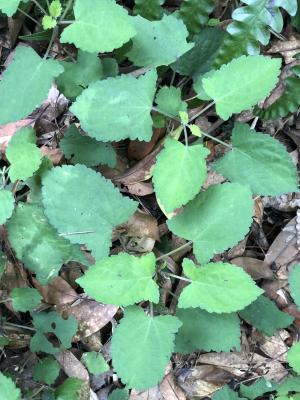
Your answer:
(33, 276), (79, 306)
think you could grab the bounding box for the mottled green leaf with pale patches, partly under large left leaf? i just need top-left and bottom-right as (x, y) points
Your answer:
(7, 203), (87, 285)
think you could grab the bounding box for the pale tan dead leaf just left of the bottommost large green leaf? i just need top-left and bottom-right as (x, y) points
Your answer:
(58, 299), (119, 341)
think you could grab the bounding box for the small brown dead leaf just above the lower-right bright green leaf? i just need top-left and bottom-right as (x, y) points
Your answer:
(230, 257), (274, 280)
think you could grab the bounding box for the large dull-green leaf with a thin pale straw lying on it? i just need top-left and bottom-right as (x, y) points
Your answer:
(42, 164), (137, 260)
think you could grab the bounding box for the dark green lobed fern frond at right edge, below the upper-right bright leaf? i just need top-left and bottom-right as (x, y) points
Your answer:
(254, 76), (300, 119)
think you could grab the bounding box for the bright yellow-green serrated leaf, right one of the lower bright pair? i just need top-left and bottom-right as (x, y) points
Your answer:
(178, 258), (263, 314)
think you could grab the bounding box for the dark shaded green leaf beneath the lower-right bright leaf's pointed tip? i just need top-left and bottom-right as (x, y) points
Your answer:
(239, 296), (294, 336)
